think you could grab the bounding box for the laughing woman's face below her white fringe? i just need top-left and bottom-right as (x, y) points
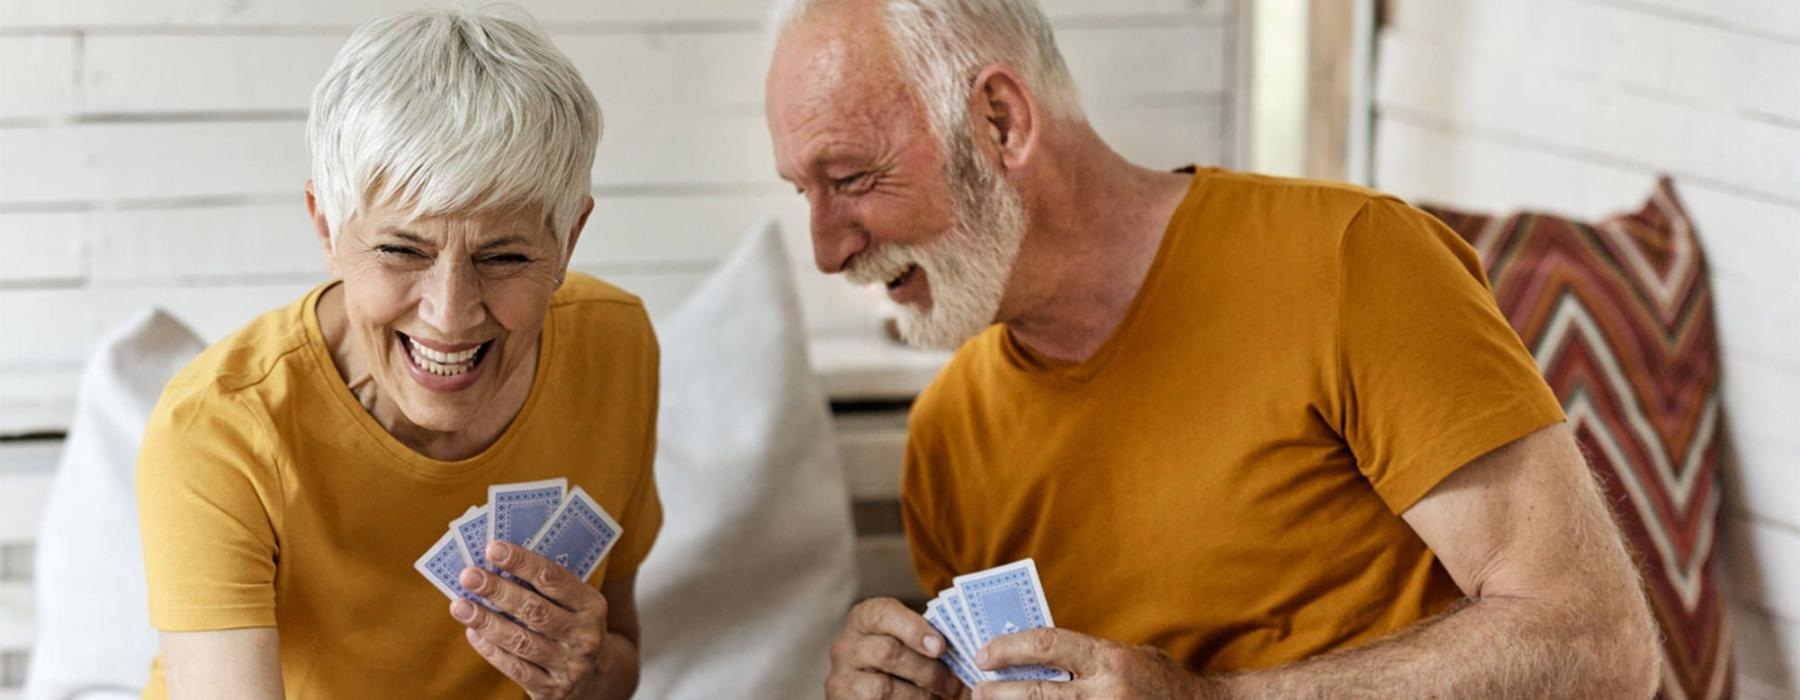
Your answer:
(316, 196), (587, 432)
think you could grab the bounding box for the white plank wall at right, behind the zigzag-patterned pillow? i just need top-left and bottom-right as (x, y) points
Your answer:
(1375, 0), (1800, 698)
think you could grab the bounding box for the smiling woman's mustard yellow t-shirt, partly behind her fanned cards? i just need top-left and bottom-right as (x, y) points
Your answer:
(137, 274), (662, 698)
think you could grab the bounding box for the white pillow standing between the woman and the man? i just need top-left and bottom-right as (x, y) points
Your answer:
(637, 221), (857, 698)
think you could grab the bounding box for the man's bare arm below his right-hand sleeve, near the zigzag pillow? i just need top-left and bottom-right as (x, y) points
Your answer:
(1219, 425), (1661, 698)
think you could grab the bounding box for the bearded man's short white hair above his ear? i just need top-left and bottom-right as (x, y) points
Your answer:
(772, 0), (1082, 144)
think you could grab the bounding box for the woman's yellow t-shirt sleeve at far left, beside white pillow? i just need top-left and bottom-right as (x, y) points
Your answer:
(137, 387), (281, 632)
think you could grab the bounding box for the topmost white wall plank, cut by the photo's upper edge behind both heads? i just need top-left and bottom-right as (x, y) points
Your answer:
(0, 0), (1231, 31)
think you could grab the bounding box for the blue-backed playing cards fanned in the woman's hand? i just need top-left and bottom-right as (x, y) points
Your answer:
(412, 479), (623, 608)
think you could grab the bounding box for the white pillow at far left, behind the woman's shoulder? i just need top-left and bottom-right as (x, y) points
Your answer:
(25, 310), (205, 700)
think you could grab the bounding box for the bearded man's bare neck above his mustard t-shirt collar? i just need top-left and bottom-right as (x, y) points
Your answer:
(1001, 140), (1192, 362)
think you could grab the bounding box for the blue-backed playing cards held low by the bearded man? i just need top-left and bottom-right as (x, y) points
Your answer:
(925, 560), (1069, 689)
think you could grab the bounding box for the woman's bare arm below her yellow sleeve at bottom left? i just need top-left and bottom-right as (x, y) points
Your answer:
(162, 626), (283, 700)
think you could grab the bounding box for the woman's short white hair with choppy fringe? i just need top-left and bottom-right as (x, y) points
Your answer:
(306, 7), (601, 254)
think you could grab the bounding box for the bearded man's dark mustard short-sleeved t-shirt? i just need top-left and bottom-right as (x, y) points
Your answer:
(904, 171), (1562, 669)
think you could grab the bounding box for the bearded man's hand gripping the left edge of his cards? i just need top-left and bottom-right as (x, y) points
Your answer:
(824, 597), (963, 700)
